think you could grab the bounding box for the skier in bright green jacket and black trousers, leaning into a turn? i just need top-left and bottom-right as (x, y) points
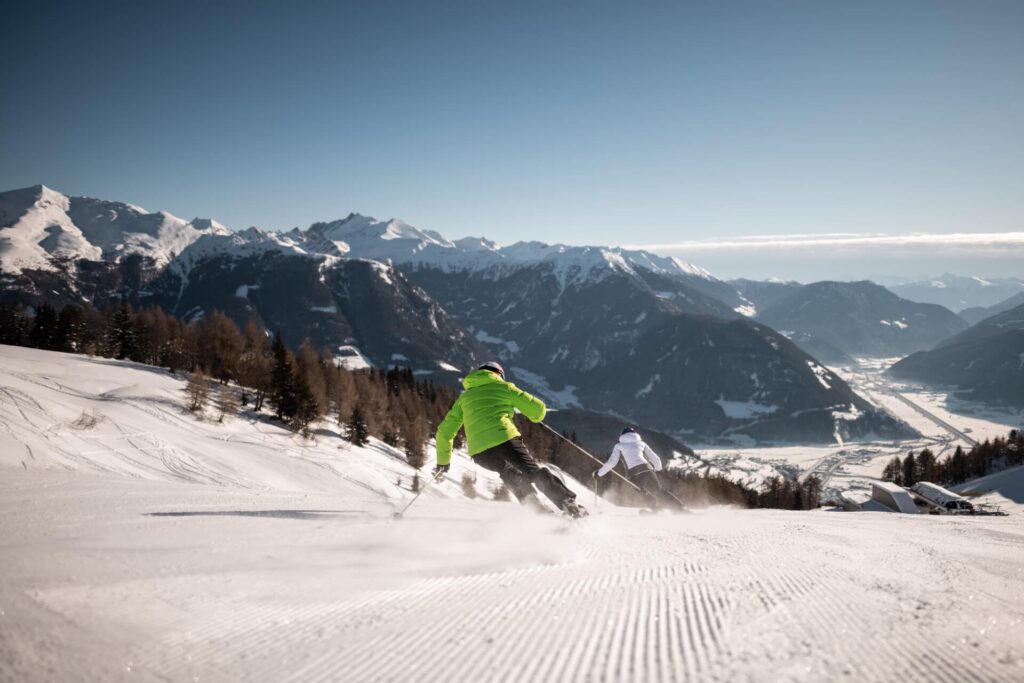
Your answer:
(434, 361), (587, 517)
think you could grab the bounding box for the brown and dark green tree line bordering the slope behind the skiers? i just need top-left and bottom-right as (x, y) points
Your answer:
(0, 302), (820, 510)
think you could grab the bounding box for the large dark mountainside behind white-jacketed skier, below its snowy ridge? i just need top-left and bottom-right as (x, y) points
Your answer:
(395, 266), (909, 440)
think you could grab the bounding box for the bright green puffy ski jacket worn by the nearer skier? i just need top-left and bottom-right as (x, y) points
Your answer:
(436, 370), (548, 465)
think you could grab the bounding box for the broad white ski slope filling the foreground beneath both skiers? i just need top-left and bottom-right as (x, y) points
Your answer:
(0, 347), (1024, 683)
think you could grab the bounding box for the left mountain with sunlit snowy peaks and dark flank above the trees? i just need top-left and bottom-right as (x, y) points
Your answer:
(0, 185), (486, 378)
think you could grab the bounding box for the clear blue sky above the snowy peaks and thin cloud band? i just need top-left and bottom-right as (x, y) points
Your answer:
(0, 0), (1024, 274)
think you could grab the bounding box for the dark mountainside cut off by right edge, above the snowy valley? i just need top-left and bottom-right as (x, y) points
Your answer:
(889, 304), (1024, 407)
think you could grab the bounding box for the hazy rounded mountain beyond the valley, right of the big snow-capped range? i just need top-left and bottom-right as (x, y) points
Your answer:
(758, 282), (967, 361)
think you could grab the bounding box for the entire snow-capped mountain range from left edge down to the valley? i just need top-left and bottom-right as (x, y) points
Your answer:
(0, 187), (907, 441)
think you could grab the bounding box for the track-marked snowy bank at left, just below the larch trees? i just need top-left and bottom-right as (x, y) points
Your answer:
(0, 346), (509, 505)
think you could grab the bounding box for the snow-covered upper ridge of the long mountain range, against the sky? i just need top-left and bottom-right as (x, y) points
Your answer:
(0, 185), (714, 286)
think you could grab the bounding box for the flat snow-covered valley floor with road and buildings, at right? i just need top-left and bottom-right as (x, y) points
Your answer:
(685, 358), (1024, 499)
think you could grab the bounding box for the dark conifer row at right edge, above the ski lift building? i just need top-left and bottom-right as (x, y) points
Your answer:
(882, 429), (1024, 487)
